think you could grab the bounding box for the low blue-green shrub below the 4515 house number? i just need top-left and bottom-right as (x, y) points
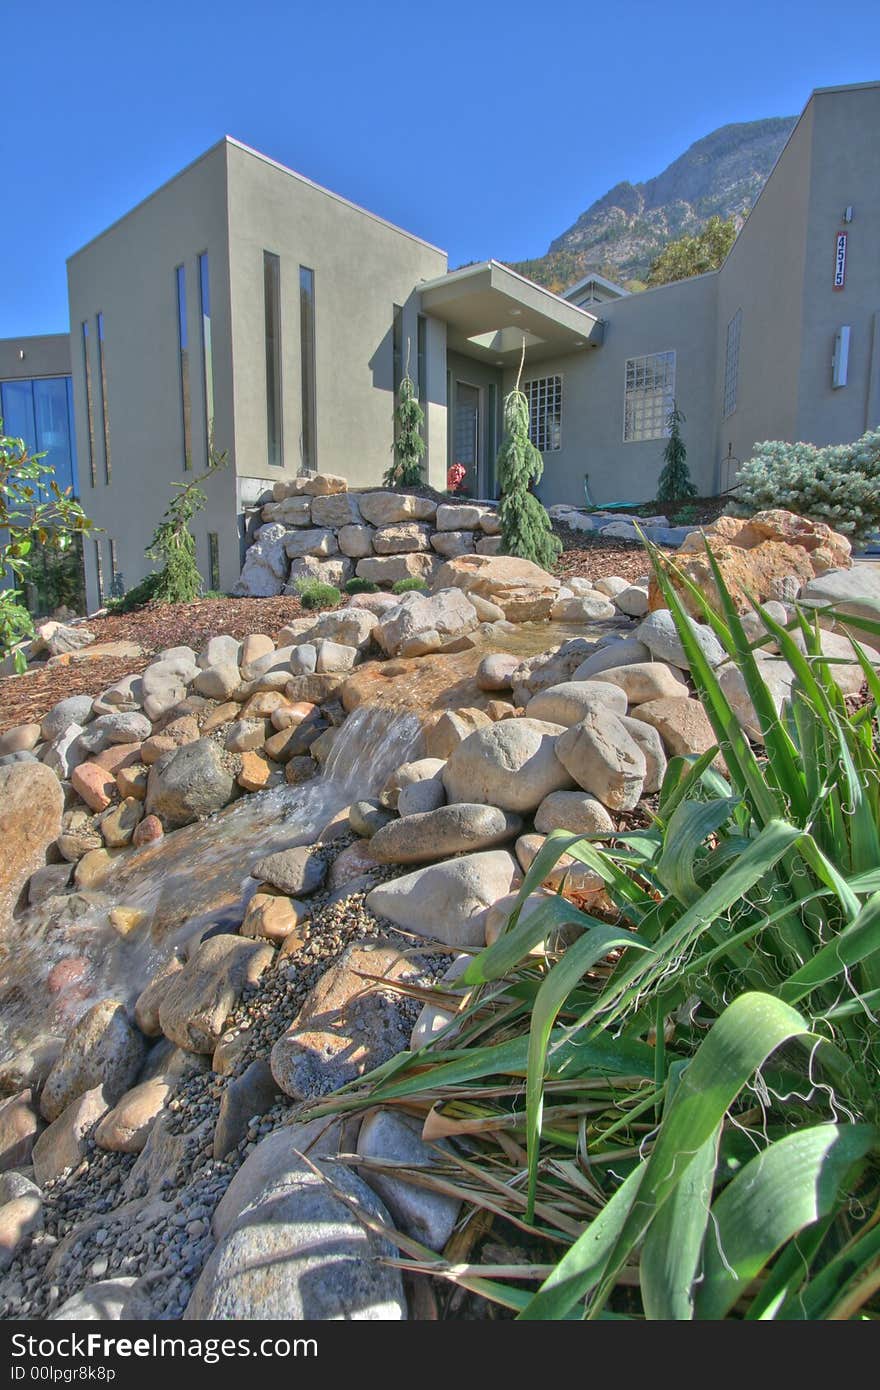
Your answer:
(727, 430), (880, 545)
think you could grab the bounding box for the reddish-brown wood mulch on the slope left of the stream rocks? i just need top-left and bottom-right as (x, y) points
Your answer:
(0, 598), (312, 734)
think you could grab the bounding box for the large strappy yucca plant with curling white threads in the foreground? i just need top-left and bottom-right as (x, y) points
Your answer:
(313, 546), (880, 1321)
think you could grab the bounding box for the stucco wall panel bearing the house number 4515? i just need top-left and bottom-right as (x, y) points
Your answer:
(795, 86), (880, 445)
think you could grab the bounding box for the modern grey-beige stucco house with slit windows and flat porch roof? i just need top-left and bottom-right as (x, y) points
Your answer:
(8, 83), (880, 606)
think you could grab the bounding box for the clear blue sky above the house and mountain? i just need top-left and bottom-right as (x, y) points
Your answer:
(0, 0), (880, 336)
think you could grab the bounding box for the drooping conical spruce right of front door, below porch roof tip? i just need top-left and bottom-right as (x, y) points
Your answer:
(498, 339), (562, 570)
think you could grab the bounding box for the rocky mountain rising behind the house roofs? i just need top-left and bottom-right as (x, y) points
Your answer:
(503, 115), (795, 291)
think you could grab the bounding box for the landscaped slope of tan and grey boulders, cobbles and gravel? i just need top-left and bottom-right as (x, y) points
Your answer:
(0, 492), (880, 1319)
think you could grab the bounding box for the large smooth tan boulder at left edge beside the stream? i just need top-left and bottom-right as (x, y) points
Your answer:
(0, 762), (64, 927)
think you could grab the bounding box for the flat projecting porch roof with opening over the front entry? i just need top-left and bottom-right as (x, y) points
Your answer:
(420, 261), (605, 367)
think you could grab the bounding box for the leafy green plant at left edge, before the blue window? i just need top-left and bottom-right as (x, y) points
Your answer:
(0, 420), (92, 671)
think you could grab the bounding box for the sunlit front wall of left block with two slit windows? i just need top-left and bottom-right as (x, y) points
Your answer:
(227, 143), (446, 497)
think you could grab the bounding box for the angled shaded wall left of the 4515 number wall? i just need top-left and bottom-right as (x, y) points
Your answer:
(713, 107), (811, 487)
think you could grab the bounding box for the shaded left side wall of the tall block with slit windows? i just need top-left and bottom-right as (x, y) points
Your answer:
(68, 143), (241, 608)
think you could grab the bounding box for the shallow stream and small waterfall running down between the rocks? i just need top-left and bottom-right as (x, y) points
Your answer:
(0, 706), (423, 1061)
